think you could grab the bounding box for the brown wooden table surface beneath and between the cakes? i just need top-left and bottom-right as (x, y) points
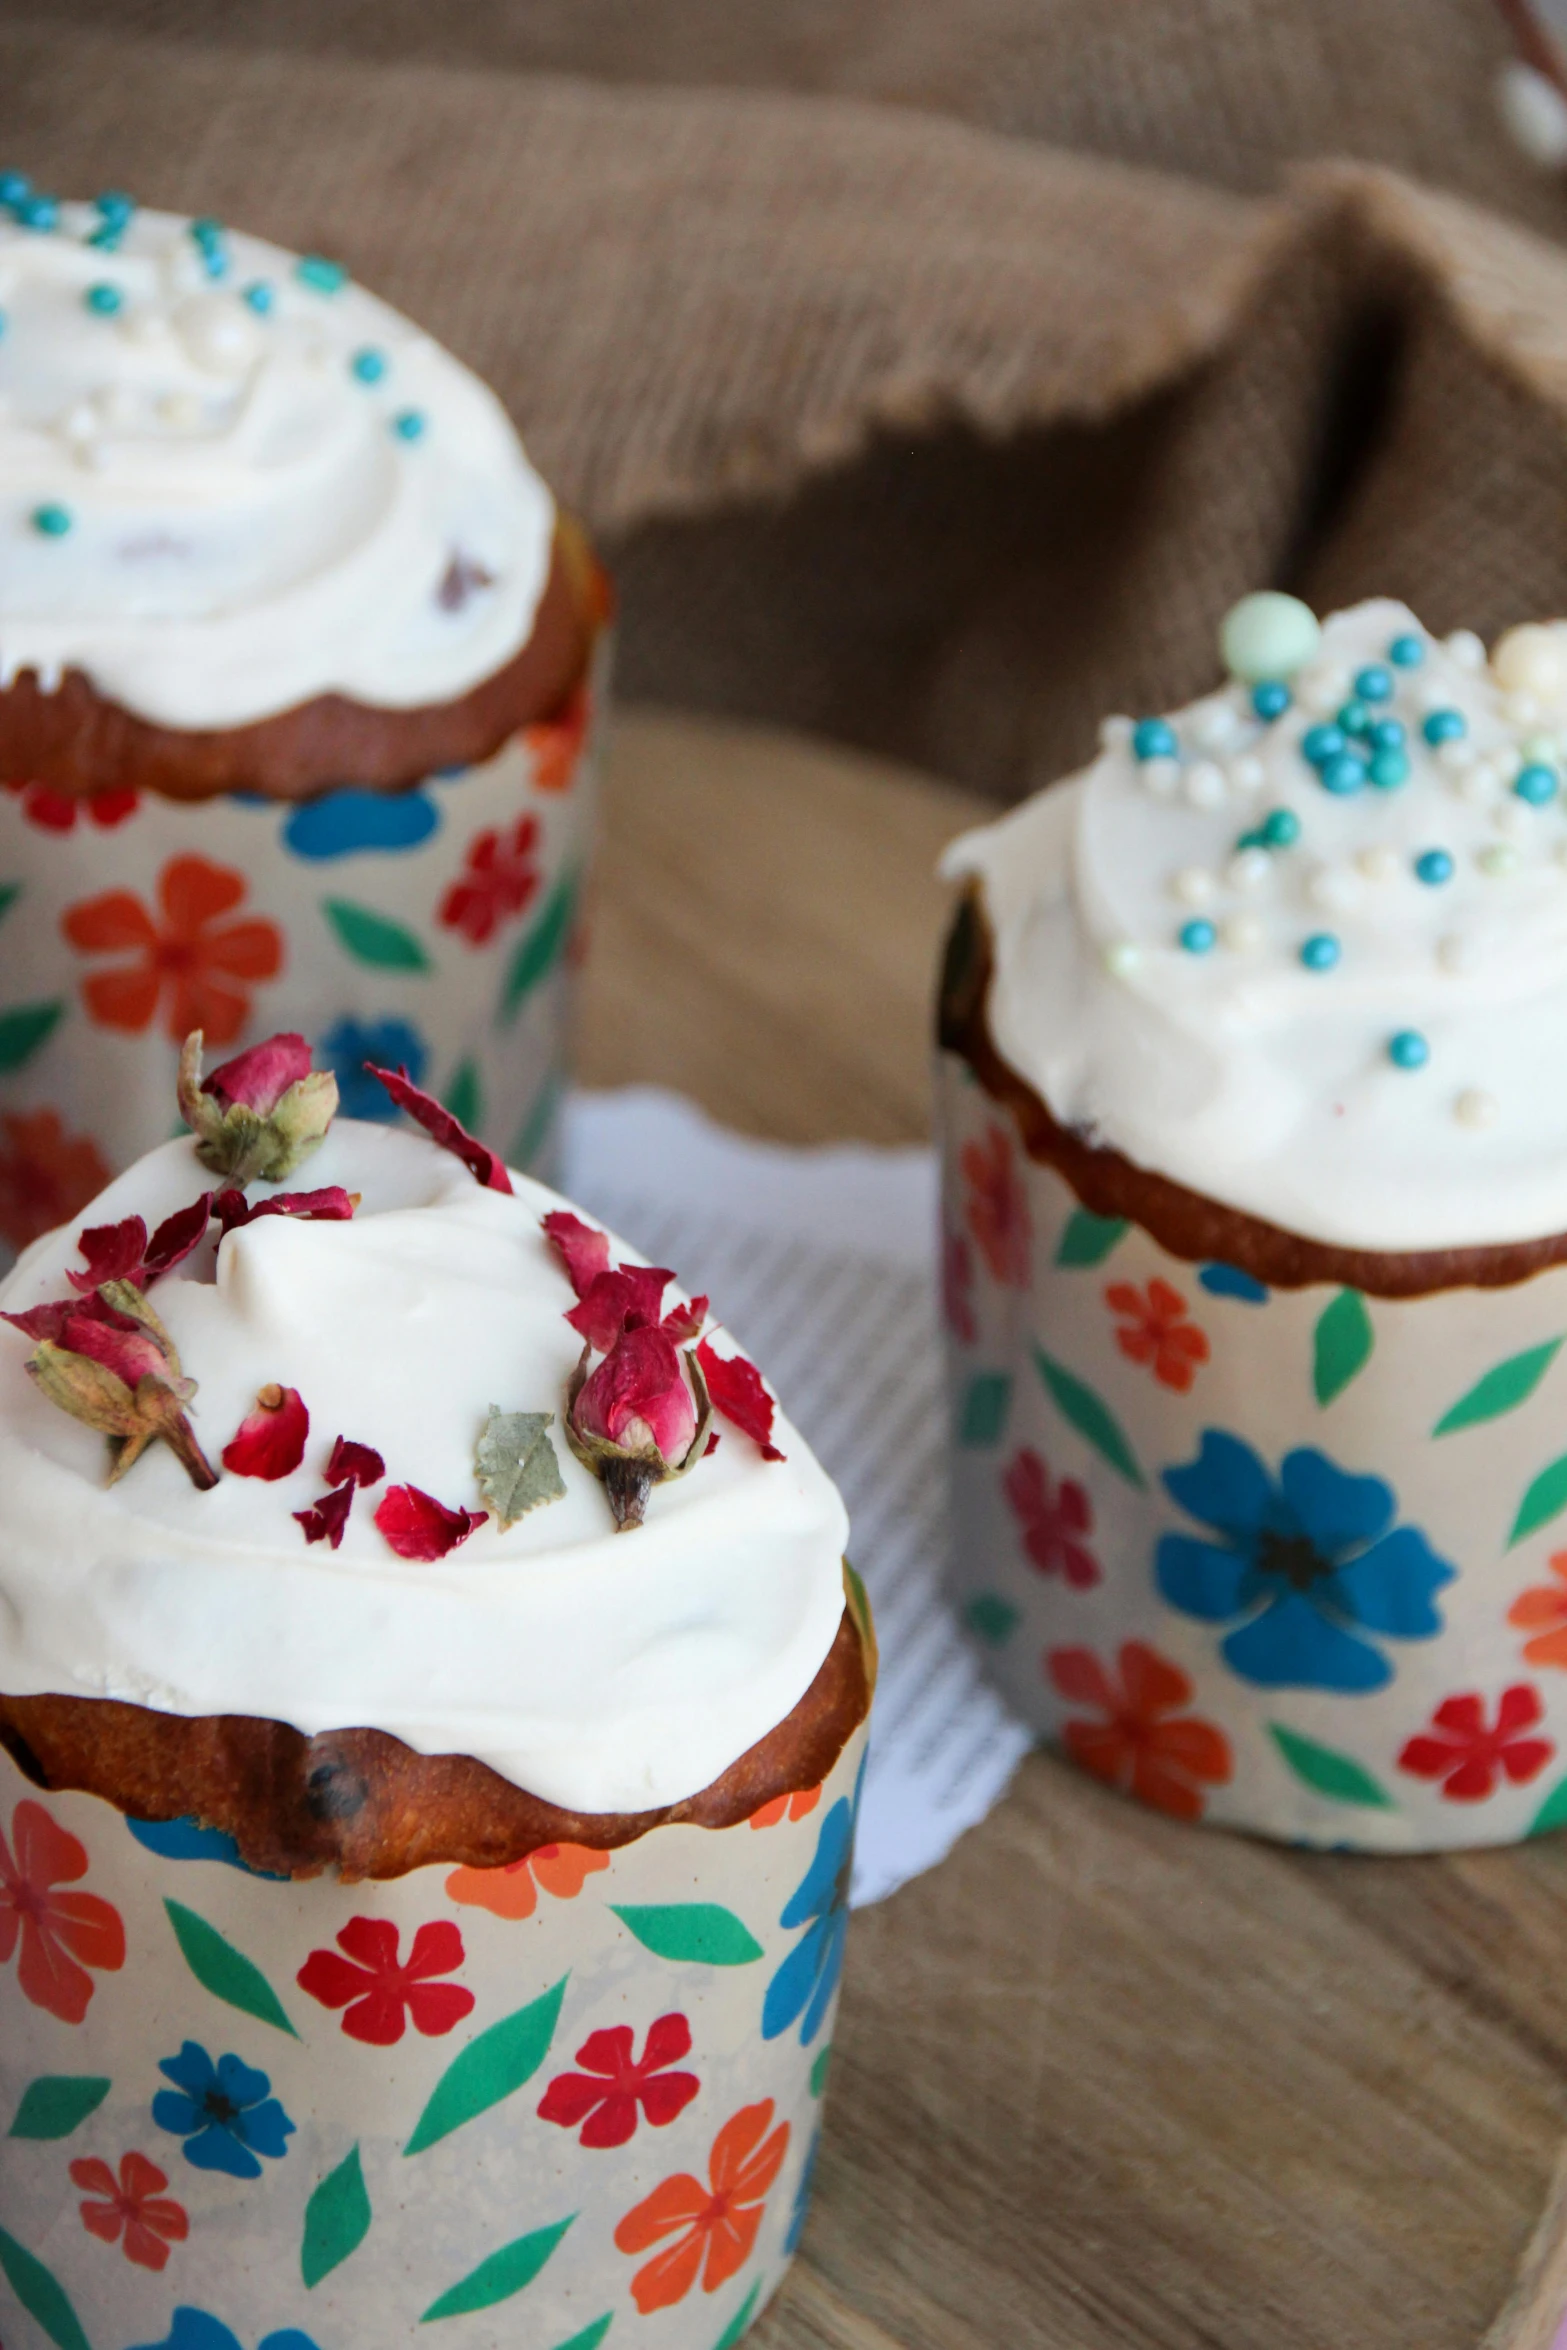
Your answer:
(583, 714), (1567, 2350)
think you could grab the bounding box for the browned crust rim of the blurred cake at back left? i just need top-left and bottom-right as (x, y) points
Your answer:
(0, 515), (608, 799)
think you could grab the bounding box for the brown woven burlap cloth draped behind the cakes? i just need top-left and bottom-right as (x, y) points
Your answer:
(0, 0), (1567, 797)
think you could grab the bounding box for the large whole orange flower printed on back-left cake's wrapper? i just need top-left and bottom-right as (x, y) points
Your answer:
(61, 858), (282, 1046)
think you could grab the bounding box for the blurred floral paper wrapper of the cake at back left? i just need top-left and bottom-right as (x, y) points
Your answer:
(0, 639), (608, 1260)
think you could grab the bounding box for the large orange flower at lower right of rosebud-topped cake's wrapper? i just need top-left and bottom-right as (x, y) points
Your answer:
(616, 2096), (789, 2317)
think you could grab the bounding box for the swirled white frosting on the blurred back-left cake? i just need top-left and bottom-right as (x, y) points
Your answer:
(0, 204), (554, 729)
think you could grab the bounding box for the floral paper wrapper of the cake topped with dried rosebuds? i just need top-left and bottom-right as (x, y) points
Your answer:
(0, 1727), (865, 2350)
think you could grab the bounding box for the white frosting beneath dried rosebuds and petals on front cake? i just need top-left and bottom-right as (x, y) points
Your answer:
(0, 1119), (848, 1812)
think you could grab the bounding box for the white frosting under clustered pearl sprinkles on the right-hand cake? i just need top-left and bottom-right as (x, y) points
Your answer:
(942, 602), (1567, 1250)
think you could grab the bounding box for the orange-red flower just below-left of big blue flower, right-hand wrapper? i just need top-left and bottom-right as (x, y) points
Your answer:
(1045, 1640), (1231, 1819)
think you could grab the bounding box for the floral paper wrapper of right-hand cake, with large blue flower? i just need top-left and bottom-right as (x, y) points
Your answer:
(940, 1055), (1567, 1852)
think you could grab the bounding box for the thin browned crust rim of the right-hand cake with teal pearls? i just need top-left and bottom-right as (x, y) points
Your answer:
(940, 888), (1567, 1297)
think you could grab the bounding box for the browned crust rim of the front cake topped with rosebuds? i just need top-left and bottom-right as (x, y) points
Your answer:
(0, 1610), (874, 1882)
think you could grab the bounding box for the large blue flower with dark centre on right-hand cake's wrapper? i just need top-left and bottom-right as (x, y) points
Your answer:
(1154, 1429), (1457, 1697)
